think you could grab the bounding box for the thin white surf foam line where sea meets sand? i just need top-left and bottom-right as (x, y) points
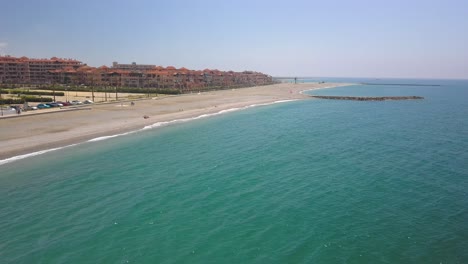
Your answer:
(0, 99), (297, 165)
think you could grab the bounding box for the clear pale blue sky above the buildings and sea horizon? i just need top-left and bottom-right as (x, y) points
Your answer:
(0, 0), (468, 79)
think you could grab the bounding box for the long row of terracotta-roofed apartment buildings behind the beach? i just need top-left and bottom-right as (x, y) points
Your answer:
(0, 56), (273, 90)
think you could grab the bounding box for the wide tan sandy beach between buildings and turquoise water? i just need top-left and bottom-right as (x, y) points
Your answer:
(0, 83), (346, 160)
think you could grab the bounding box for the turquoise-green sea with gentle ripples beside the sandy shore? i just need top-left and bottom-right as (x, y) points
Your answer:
(0, 79), (468, 264)
